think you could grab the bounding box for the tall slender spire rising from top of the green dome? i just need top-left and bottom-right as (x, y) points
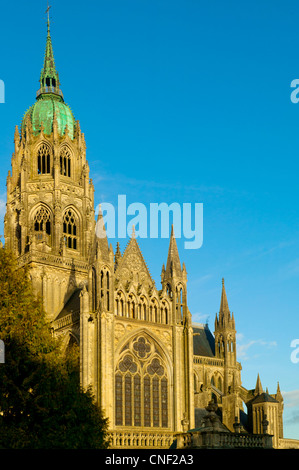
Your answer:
(37, 5), (63, 98)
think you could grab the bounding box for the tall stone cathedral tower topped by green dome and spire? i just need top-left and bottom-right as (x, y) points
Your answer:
(4, 15), (95, 320)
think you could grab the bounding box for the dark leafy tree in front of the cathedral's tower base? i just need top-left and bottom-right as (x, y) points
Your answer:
(0, 248), (108, 449)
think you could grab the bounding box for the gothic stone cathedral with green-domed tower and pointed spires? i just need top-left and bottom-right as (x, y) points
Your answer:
(4, 13), (298, 449)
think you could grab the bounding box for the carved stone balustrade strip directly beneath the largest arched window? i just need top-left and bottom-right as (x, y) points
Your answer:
(109, 431), (174, 449)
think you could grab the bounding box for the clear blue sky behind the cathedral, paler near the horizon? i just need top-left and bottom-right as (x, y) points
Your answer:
(0, 0), (299, 439)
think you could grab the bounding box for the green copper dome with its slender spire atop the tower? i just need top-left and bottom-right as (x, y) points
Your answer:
(22, 16), (75, 139)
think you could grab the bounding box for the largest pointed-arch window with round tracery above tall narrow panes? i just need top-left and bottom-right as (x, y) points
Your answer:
(115, 335), (169, 428)
